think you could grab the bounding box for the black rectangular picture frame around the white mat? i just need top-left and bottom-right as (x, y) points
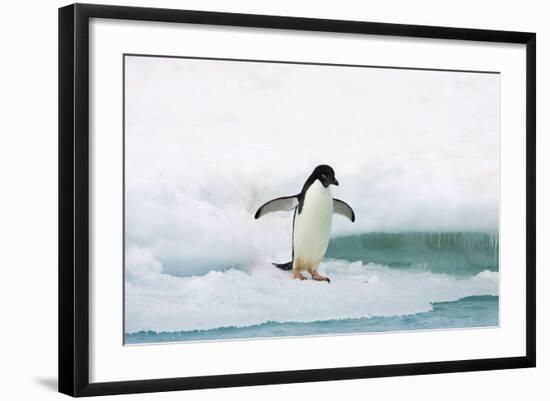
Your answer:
(58, 4), (536, 396)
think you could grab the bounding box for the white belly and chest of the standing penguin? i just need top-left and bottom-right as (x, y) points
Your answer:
(292, 181), (332, 271)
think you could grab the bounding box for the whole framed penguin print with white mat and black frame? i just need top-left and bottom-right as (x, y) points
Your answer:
(59, 4), (536, 396)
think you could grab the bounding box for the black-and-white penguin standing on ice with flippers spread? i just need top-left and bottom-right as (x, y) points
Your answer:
(254, 164), (355, 283)
